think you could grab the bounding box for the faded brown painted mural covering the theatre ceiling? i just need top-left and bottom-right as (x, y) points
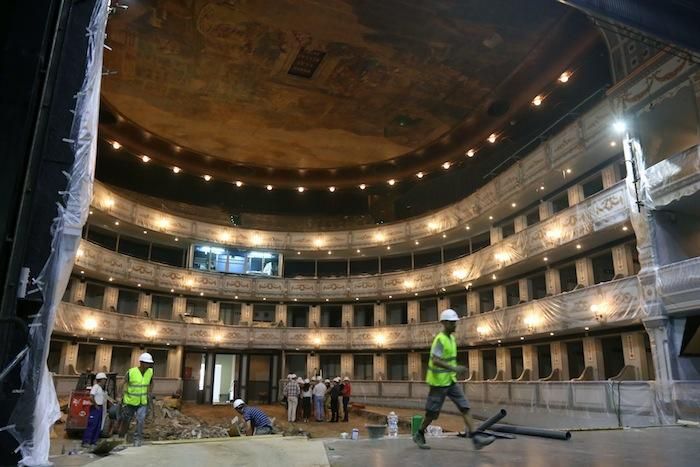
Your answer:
(103, 0), (565, 168)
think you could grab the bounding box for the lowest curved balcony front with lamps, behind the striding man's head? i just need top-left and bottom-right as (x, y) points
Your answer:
(54, 277), (644, 351)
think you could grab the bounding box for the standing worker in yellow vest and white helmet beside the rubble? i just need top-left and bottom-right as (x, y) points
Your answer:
(119, 352), (153, 447)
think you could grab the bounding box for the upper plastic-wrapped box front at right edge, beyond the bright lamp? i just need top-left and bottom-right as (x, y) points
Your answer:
(646, 146), (700, 209)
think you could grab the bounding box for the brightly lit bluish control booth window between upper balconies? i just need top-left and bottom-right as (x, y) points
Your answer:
(192, 245), (282, 277)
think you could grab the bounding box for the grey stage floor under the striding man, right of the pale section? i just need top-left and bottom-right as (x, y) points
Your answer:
(326, 427), (700, 467)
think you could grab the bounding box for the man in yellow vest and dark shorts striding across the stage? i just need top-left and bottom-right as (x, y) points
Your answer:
(413, 308), (494, 449)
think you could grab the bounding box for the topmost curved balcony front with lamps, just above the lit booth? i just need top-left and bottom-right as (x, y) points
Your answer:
(92, 101), (613, 251)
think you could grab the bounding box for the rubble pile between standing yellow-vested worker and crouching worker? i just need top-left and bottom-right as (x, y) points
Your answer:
(144, 400), (230, 441)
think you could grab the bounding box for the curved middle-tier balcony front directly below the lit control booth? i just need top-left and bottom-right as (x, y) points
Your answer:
(76, 182), (629, 300)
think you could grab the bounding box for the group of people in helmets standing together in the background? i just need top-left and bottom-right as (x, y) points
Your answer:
(283, 374), (352, 423)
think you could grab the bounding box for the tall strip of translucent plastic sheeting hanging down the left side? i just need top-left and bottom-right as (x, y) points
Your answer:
(5, 0), (109, 465)
